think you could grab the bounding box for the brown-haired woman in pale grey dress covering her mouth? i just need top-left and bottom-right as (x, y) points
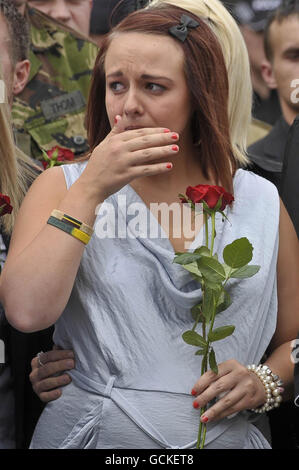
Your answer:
(1, 5), (299, 448)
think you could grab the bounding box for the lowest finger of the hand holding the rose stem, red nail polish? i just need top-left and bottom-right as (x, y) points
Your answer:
(201, 388), (248, 423)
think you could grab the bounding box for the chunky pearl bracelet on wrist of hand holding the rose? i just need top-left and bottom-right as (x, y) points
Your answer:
(247, 364), (284, 413)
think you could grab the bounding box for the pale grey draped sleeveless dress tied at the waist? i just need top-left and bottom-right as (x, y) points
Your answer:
(31, 163), (279, 449)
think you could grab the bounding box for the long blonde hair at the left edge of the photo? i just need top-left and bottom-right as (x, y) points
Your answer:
(0, 63), (38, 235)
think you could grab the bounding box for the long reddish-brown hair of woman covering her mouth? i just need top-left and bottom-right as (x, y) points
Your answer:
(86, 5), (236, 191)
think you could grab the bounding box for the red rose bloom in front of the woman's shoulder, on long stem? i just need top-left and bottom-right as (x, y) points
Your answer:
(186, 184), (234, 211)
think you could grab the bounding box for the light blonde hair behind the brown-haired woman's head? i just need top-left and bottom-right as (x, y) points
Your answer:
(148, 0), (252, 166)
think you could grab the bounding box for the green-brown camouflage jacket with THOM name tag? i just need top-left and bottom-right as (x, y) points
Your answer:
(12, 9), (98, 159)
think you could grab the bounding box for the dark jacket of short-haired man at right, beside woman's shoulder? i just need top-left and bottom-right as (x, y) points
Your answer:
(248, 116), (290, 193)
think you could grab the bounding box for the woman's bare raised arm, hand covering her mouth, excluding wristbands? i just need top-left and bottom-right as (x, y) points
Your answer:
(0, 122), (178, 332)
